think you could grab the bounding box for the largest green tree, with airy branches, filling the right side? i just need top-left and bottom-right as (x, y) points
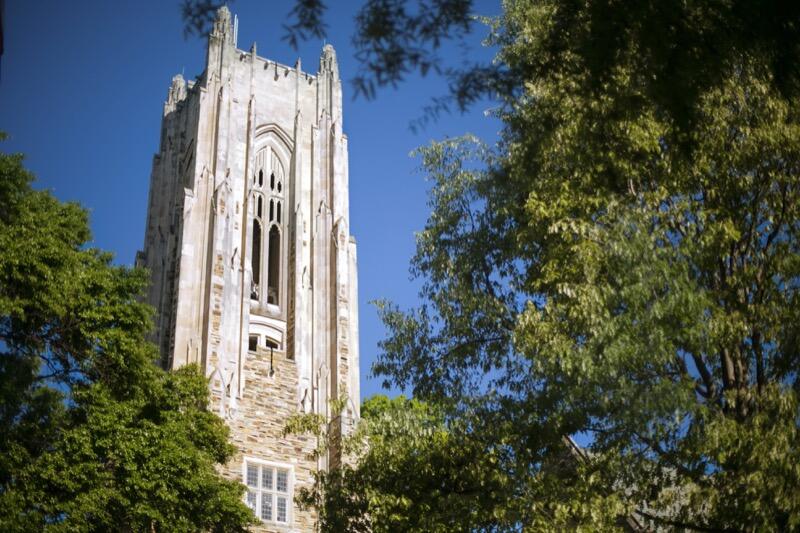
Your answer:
(374, 1), (800, 531)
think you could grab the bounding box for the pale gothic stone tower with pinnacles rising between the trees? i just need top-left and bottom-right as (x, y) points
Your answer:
(137, 7), (359, 532)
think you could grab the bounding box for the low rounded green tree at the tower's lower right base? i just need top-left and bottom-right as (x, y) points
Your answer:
(289, 395), (508, 533)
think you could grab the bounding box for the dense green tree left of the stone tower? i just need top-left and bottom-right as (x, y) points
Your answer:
(0, 138), (252, 532)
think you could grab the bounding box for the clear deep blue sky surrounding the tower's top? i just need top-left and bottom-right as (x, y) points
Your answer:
(0, 0), (500, 398)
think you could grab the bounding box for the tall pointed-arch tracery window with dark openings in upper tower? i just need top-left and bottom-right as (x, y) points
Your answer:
(250, 149), (285, 307)
